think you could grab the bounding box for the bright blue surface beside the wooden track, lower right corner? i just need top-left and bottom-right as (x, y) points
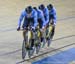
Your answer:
(32, 48), (75, 64)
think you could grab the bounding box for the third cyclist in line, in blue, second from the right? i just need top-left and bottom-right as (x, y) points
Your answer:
(39, 4), (49, 46)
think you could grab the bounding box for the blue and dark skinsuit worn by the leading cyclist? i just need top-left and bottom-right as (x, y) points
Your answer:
(18, 9), (37, 28)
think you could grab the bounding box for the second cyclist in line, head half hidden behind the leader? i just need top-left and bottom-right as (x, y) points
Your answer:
(33, 7), (45, 46)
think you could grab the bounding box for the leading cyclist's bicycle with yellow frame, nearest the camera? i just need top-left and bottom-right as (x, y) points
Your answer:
(22, 26), (33, 59)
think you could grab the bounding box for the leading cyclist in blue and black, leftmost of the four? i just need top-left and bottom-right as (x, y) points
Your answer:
(17, 6), (37, 47)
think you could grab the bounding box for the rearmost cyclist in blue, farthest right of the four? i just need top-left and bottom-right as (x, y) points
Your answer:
(47, 4), (57, 39)
